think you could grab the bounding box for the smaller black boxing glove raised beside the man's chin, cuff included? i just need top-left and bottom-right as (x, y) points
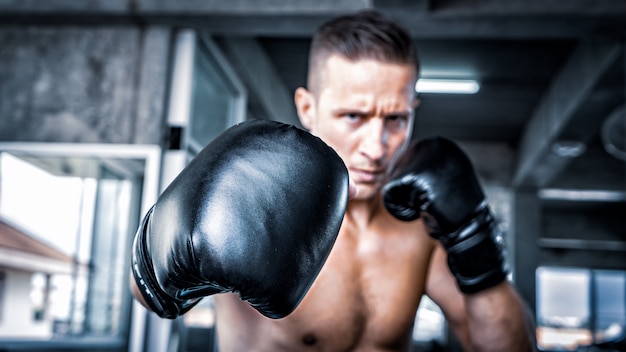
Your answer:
(383, 137), (509, 293)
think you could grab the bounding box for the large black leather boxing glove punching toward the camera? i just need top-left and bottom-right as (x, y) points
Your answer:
(132, 120), (349, 319)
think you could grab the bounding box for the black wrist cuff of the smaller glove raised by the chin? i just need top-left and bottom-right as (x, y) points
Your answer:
(439, 206), (509, 293)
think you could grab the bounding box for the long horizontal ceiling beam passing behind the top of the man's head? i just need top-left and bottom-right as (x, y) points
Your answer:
(0, 14), (626, 40)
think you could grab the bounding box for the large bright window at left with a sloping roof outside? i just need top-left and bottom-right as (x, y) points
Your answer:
(0, 143), (159, 350)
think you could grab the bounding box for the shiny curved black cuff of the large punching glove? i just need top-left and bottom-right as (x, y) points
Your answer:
(132, 207), (200, 319)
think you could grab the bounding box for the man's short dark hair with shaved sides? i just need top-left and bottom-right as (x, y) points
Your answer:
(308, 10), (419, 88)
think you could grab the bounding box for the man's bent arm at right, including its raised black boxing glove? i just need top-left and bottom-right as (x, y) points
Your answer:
(384, 137), (534, 351)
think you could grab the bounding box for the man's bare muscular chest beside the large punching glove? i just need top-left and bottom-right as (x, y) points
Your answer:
(272, 221), (430, 350)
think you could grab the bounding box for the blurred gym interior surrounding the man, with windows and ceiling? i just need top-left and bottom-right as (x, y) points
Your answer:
(0, 0), (626, 352)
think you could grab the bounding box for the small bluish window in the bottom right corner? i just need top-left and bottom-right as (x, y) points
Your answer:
(536, 267), (626, 351)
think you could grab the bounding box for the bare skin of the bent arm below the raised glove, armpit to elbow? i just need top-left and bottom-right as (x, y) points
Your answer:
(426, 245), (536, 351)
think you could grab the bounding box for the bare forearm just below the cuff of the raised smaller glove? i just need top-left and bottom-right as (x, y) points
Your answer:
(464, 282), (536, 352)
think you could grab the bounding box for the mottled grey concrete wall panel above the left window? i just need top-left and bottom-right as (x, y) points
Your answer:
(0, 26), (170, 144)
